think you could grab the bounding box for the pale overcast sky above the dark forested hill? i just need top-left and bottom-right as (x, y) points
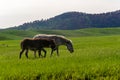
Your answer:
(0, 0), (120, 28)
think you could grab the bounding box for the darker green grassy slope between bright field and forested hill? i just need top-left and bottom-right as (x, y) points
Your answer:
(0, 28), (120, 40)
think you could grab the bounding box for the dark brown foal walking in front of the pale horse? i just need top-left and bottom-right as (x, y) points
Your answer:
(19, 38), (56, 58)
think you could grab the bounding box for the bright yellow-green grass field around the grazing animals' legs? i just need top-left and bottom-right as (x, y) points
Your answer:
(0, 35), (120, 80)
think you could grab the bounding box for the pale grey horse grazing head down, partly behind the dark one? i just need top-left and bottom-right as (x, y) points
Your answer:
(33, 34), (74, 56)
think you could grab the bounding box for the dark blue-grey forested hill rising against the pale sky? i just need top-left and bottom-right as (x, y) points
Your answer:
(11, 10), (120, 30)
